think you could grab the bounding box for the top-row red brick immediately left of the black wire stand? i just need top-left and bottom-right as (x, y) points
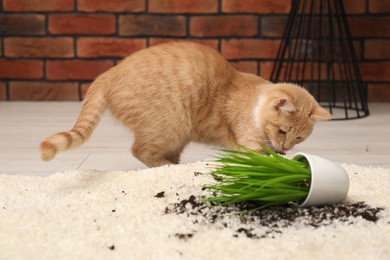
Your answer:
(222, 0), (291, 14)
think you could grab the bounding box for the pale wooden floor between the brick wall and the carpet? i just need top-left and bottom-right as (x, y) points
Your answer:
(0, 102), (390, 176)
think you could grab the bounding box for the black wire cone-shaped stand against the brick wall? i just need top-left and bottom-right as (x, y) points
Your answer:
(271, 0), (369, 120)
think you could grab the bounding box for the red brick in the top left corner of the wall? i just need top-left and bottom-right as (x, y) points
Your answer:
(3, 0), (74, 12)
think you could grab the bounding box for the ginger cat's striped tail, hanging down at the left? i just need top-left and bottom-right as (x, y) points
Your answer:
(40, 77), (107, 161)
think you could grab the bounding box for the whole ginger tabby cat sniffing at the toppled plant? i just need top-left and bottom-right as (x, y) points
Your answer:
(40, 42), (331, 167)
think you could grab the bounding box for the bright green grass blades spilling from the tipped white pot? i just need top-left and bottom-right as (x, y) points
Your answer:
(204, 147), (311, 209)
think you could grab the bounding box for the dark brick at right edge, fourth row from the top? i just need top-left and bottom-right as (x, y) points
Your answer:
(359, 62), (390, 82)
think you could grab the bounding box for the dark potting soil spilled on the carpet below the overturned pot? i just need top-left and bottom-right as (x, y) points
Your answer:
(165, 195), (383, 240)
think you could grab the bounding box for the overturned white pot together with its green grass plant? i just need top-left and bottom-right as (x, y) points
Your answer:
(205, 147), (349, 209)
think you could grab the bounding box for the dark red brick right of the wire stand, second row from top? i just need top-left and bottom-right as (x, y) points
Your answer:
(348, 16), (390, 37)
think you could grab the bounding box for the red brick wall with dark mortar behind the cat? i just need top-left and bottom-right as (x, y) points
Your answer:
(0, 0), (390, 102)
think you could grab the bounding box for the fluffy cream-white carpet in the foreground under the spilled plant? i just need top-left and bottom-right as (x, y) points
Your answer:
(0, 162), (390, 259)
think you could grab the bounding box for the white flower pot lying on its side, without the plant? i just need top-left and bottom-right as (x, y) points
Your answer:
(292, 153), (349, 207)
